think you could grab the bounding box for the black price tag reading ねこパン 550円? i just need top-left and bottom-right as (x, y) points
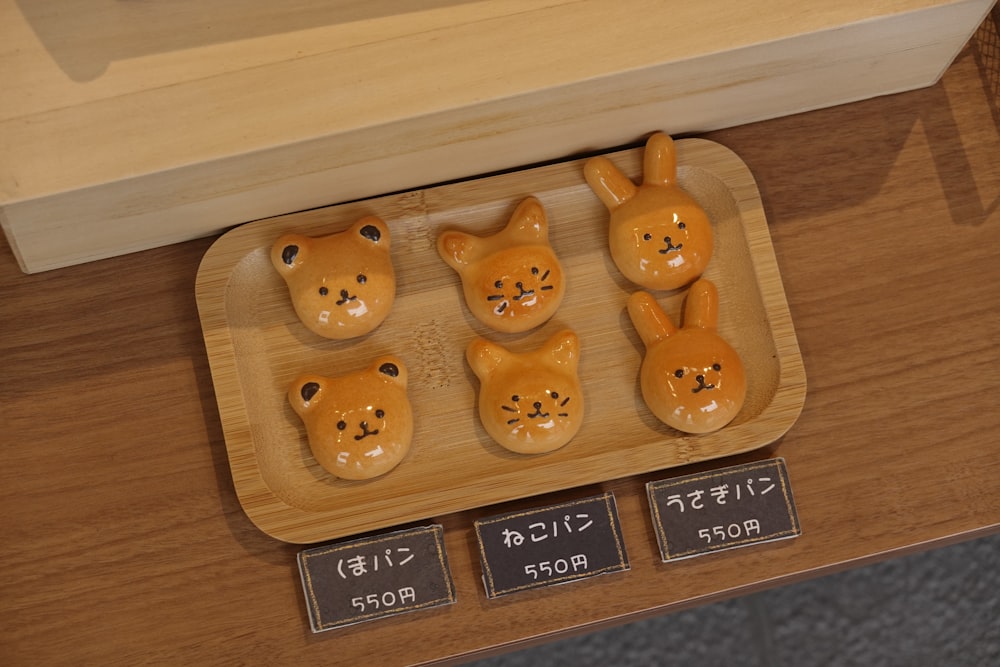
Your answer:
(475, 493), (629, 598)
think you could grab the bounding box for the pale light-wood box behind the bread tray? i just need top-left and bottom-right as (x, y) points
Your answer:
(0, 0), (993, 272)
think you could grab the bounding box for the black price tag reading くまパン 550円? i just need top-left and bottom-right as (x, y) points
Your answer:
(298, 525), (455, 632)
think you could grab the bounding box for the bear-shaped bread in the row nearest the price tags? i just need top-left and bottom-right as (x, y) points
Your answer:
(288, 356), (413, 480)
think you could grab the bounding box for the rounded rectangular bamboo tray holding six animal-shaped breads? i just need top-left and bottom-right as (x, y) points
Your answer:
(196, 139), (806, 543)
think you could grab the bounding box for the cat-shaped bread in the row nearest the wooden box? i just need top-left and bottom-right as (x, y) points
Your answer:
(437, 197), (566, 333)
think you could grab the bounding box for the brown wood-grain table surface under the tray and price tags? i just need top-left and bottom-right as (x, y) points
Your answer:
(0, 23), (1000, 665)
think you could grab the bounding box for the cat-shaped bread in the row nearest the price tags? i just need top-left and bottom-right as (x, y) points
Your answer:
(465, 330), (584, 454)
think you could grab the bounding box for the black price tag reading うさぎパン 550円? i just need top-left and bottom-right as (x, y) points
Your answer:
(646, 459), (802, 561)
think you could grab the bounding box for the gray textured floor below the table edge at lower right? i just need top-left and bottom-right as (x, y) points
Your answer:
(470, 535), (1000, 667)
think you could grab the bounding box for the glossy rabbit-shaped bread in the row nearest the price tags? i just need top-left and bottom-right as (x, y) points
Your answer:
(628, 278), (747, 433)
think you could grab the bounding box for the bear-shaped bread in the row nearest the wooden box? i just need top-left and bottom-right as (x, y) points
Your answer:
(271, 216), (396, 340)
